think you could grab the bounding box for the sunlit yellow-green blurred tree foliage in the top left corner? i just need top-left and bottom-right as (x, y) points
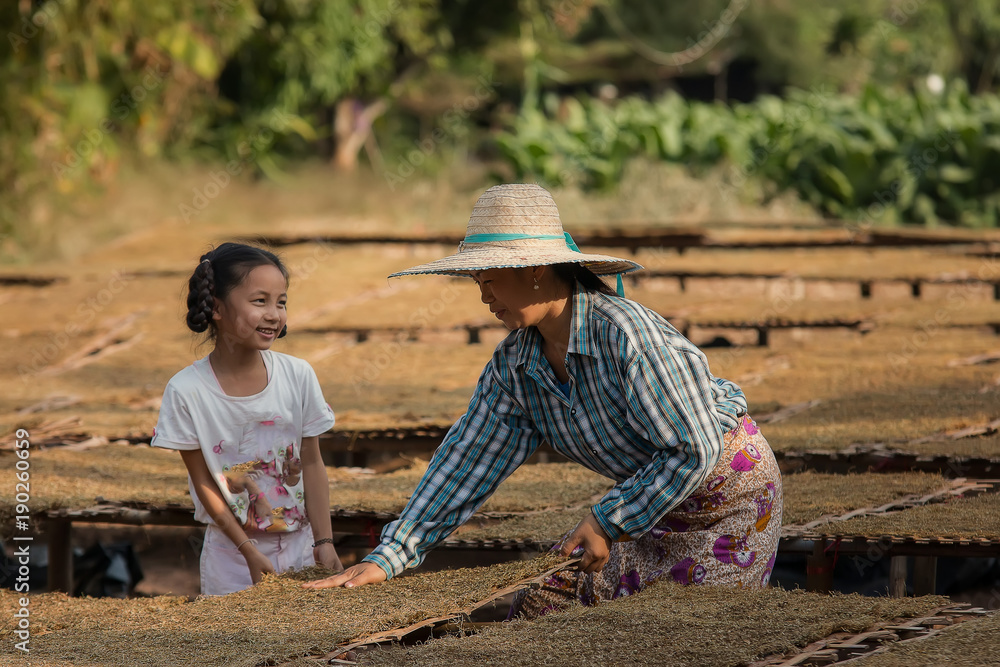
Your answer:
(0, 0), (259, 243)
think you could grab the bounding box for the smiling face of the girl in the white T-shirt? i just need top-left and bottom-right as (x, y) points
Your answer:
(212, 264), (288, 350)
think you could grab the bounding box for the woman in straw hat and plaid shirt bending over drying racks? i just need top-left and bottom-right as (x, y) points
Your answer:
(307, 184), (781, 613)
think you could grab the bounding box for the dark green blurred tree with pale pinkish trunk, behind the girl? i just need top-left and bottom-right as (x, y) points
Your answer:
(219, 0), (450, 169)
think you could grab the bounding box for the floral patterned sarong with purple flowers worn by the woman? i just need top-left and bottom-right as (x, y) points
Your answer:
(511, 416), (782, 618)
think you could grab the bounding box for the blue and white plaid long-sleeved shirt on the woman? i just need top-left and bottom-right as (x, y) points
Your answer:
(365, 288), (747, 577)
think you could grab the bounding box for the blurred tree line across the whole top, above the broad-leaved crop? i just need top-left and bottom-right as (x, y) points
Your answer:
(0, 0), (1000, 244)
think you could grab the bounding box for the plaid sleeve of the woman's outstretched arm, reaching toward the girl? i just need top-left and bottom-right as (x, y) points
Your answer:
(364, 362), (540, 577)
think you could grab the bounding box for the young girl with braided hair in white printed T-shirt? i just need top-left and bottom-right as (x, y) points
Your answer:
(151, 243), (343, 595)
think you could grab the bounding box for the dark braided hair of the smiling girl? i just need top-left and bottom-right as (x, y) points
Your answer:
(187, 243), (288, 338)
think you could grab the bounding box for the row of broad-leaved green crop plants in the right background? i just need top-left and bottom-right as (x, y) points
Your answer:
(497, 86), (1000, 226)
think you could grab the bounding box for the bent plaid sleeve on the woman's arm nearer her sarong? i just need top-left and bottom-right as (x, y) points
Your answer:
(593, 345), (725, 540)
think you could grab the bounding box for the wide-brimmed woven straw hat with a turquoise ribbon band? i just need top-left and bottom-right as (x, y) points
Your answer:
(389, 183), (642, 278)
